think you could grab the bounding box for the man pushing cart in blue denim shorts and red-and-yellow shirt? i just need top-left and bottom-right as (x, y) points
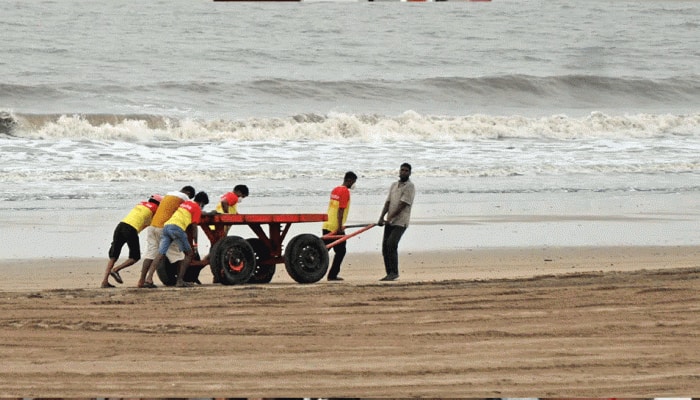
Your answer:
(144, 192), (209, 287)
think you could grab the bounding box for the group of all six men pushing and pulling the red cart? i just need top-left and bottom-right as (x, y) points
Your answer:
(101, 163), (415, 288)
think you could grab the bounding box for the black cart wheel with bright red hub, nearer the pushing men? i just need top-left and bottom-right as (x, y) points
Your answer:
(210, 236), (255, 285)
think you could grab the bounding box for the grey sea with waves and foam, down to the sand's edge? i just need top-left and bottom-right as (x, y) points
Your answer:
(0, 0), (700, 258)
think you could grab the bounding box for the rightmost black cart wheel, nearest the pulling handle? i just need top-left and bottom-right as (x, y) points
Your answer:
(284, 233), (328, 283)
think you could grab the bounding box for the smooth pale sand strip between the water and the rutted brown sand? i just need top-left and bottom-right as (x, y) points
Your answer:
(0, 246), (700, 292)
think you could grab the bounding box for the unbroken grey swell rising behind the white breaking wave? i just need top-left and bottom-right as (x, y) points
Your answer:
(5, 74), (700, 118)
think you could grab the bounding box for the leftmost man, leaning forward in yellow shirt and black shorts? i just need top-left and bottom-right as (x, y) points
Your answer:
(101, 194), (163, 288)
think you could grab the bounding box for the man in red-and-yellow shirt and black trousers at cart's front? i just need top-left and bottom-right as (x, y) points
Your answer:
(323, 171), (357, 281)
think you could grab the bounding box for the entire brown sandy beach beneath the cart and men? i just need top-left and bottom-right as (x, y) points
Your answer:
(0, 247), (700, 397)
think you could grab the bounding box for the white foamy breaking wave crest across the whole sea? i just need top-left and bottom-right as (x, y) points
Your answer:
(0, 111), (700, 143)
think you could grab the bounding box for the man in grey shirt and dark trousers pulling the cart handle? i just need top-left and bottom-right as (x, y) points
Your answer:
(377, 163), (416, 281)
